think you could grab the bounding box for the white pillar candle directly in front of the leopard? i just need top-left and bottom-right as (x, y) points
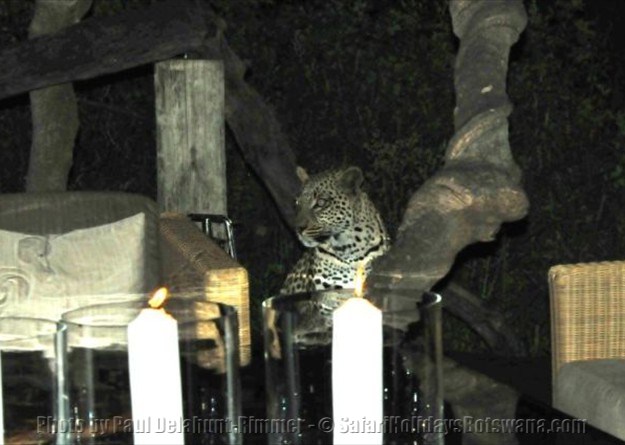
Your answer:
(332, 297), (384, 445)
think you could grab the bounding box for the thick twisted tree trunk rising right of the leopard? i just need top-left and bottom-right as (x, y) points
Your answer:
(367, 0), (528, 293)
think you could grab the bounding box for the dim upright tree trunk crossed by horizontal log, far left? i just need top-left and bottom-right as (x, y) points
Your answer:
(26, 0), (91, 192)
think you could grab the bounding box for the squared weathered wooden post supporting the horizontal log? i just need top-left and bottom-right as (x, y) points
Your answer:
(154, 59), (227, 219)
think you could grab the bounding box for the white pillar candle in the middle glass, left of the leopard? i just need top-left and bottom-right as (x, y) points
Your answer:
(128, 290), (184, 445)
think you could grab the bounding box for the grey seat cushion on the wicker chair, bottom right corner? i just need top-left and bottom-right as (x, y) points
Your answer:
(553, 359), (625, 440)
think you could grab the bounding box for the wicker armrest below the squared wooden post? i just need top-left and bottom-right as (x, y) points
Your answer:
(160, 213), (251, 365)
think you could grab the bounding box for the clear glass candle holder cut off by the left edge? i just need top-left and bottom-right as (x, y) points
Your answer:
(0, 317), (65, 445)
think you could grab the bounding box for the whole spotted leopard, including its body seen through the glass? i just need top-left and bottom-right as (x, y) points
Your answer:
(265, 166), (390, 358)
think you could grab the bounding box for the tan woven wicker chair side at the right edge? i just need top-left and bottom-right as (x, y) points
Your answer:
(549, 261), (625, 383)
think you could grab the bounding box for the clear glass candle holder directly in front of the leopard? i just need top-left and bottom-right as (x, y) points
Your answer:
(263, 290), (444, 445)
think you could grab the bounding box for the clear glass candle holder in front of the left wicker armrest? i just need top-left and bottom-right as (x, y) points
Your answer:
(61, 297), (241, 445)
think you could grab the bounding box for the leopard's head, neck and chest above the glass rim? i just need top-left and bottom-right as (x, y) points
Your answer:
(280, 166), (390, 294)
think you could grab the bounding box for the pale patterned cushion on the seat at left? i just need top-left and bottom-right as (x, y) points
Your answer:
(0, 213), (146, 319)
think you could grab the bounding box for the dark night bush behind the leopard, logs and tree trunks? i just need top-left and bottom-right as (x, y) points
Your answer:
(0, 0), (625, 364)
